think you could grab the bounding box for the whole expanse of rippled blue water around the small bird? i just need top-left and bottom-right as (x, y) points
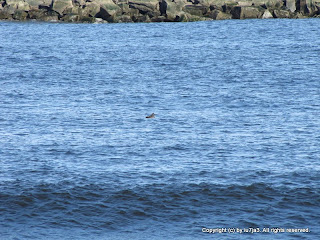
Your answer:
(0, 19), (320, 240)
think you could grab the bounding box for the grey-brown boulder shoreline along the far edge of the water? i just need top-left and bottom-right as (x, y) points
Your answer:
(0, 0), (320, 23)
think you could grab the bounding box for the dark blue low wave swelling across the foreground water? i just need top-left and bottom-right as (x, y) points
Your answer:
(0, 181), (320, 237)
